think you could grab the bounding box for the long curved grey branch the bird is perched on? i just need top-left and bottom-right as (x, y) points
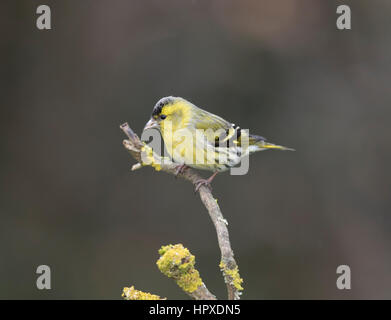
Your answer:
(120, 123), (243, 300)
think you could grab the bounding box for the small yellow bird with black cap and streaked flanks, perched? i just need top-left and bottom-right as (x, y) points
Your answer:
(143, 96), (294, 192)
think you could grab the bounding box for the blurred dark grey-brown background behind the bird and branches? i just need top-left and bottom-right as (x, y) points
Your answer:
(0, 0), (391, 299)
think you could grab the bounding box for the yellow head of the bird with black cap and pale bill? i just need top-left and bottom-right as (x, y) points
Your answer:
(143, 97), (190, 131)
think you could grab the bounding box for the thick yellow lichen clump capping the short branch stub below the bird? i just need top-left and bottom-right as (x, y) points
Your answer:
(156, 244), (202, 293)
